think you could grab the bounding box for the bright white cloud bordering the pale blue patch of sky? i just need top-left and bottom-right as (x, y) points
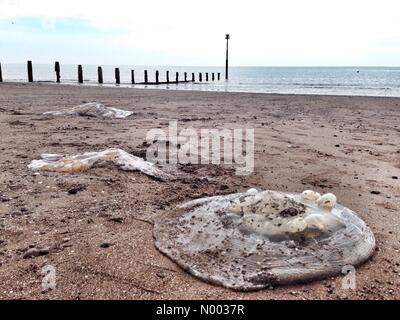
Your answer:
(0, 0), (400, 65)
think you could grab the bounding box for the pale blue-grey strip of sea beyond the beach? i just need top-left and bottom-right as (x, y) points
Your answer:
(2, 64), (400, 97)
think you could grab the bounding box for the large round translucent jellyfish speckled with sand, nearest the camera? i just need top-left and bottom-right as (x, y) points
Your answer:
(154, 189), (375, 291)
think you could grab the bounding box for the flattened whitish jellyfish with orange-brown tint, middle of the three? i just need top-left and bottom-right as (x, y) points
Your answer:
(28, 148), (170, 180)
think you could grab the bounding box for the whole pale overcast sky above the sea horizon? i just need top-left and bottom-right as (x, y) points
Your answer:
(0, 0), (400, 66)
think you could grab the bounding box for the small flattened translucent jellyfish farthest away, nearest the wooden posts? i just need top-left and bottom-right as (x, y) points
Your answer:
(43, 102), (133, 119)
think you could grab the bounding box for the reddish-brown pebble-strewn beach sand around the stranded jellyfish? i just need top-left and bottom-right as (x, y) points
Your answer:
(0, 83), (400, 299)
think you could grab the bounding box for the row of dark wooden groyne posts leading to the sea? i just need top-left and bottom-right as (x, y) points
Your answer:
(0, 61), (221, 85)
